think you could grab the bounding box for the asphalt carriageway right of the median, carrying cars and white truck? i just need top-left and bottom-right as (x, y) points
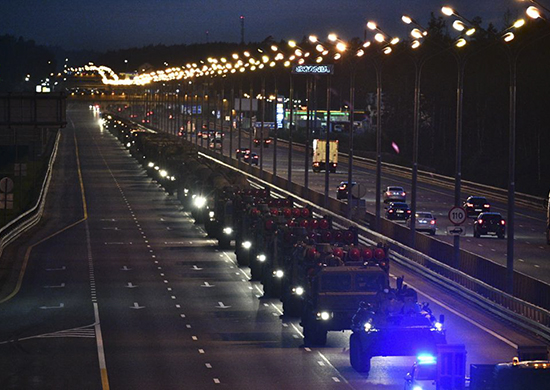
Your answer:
(204, 131), (550, 283)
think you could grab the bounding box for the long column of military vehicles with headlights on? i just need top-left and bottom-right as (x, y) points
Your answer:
(105, 109), (444, 356)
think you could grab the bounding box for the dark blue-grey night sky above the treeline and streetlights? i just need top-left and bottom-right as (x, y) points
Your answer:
(0, 0), (527, 51)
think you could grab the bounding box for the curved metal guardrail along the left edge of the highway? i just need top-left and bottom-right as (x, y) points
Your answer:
(0, 132), (61, 257)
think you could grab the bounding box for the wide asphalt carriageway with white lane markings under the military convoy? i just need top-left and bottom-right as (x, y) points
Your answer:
(0, 105), (539, 390)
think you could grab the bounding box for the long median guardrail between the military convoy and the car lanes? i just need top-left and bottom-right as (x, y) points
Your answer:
(201, 150), (550, 342)
